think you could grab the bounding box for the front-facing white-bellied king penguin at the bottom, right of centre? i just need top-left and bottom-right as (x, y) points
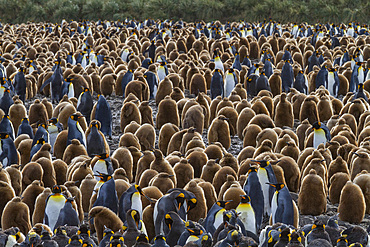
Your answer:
(236, 195), (257, 234)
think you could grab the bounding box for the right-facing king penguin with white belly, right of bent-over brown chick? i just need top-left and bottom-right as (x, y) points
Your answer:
(119, 184), (151, 222)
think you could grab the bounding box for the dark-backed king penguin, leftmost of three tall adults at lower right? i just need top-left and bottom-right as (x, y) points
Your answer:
(243, 166), (265, 232)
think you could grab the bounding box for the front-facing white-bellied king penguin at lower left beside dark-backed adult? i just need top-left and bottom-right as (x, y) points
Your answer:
(43, 185), (67, 231)
